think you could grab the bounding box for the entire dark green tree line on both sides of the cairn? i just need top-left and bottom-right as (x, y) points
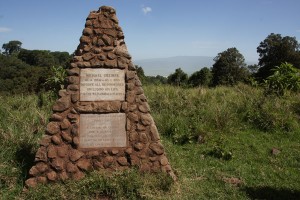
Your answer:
(0, 33), (300, 93)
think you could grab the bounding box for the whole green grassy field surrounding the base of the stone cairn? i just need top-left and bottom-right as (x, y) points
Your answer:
(0, 85), (300, 199)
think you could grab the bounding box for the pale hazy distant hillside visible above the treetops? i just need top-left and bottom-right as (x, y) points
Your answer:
(134, 56), (214, 76)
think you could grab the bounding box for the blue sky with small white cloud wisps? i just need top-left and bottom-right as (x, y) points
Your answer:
(0, 0), (300, 62)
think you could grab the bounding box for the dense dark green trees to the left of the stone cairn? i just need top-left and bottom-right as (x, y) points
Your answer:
(0, 40), (71, 94)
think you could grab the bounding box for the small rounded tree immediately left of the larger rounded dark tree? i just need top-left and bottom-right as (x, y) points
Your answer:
(188, 67), (212, 87)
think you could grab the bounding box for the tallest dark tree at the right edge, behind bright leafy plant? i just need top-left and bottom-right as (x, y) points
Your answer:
(256, 33), (300, 80)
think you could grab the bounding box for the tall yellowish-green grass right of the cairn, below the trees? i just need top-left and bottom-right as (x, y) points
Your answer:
(145, 85), (300, 144)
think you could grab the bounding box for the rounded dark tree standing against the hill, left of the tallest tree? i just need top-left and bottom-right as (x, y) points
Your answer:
(212, 47), (249, 86)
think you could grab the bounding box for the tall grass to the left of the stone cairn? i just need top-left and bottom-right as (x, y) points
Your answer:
(0, 94), (53, 198)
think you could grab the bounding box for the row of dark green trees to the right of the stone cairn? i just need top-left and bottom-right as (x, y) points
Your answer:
(137, 33), (300, 88)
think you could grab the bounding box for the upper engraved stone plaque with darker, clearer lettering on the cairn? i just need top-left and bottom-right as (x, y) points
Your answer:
(80, 69), (125, 101)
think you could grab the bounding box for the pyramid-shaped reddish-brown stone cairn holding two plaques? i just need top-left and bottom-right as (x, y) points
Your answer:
(26, 6), (175, 187)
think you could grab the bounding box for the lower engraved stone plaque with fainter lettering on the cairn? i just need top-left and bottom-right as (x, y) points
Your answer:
(79, 113), (127, 148)
